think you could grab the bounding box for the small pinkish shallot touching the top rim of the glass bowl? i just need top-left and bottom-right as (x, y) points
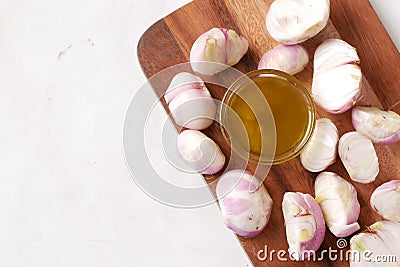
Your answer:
(258, 44), (309, 75)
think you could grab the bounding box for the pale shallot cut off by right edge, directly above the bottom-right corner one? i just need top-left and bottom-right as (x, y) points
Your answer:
(370, 180), (400, 222)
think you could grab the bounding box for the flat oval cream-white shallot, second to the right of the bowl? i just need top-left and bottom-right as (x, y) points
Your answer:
(338, 132), (379, 184)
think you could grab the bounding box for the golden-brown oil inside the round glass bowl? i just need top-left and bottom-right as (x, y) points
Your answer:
(226, 76), (310, 156)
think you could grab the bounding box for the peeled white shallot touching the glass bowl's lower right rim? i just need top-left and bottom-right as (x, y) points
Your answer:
(300, 118), (339, 172)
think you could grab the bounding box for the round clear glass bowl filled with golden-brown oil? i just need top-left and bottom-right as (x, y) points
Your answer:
(220, 69), (315, 164)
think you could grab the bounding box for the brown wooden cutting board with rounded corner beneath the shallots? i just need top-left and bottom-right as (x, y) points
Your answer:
(138, 0), (400, 266)
